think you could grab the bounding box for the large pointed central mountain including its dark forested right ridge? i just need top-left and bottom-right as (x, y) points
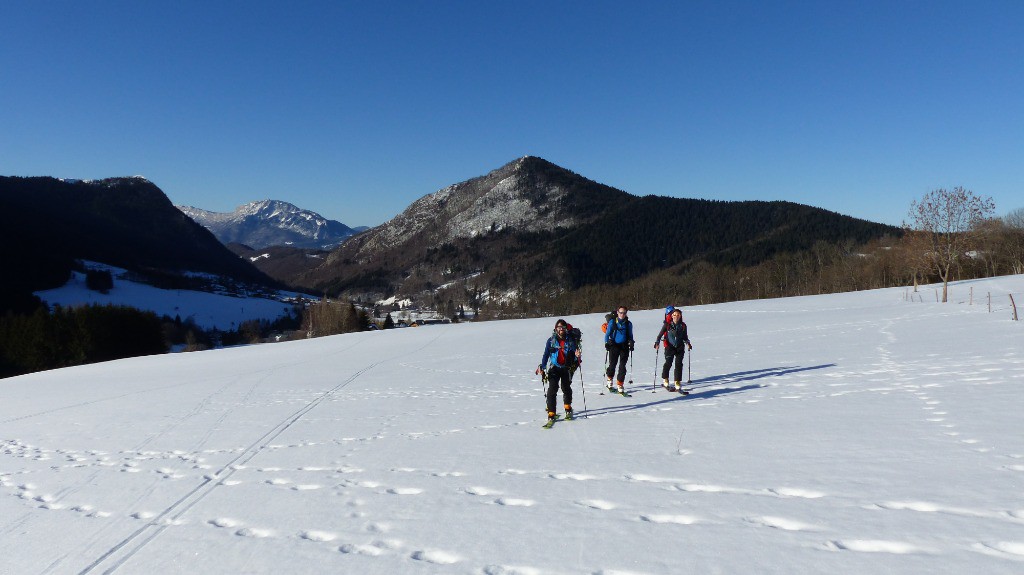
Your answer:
(299, 152), (899, 299)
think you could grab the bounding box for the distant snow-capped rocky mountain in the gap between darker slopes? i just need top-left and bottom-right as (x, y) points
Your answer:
(177, 200), (366, 250)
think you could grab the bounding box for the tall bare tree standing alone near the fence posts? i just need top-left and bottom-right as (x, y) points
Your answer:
(909, 186), (995, 303)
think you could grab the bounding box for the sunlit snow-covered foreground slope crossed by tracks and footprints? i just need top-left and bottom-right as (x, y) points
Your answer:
(0, 276), (1024, 575)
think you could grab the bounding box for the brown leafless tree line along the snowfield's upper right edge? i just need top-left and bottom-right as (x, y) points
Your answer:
(471, 202), (1024, 319)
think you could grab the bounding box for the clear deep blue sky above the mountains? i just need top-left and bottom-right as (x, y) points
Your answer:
(0, 0), (1024, 225)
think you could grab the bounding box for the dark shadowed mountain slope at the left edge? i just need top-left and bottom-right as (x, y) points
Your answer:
(0, 177), (273, 311)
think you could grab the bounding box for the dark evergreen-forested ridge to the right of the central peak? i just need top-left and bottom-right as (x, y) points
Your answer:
(556, 195), (899, 289)
